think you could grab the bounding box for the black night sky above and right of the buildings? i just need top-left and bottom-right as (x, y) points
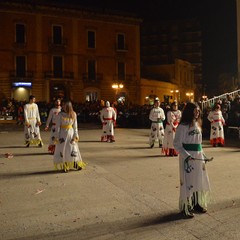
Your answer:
(56, 0), (237, 91)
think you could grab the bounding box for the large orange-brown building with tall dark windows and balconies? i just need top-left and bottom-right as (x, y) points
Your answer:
(0, 0), (140, 103)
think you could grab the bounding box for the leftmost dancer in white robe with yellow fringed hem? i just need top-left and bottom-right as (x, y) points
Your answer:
(24, 95), (43, 147)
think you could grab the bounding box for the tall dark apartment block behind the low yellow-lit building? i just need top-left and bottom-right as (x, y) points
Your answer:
(141, 19), (203, 99)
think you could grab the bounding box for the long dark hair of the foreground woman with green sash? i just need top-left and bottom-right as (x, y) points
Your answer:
(180, 102), (202, 127)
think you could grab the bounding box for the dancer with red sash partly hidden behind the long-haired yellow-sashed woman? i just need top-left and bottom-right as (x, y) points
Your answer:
(45, 99), (61, 154)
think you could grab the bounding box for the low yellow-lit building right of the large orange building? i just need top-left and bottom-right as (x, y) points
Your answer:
(141, 59), (196, 104)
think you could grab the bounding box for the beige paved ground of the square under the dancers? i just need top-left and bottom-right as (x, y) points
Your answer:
(0, 125), (240, 240)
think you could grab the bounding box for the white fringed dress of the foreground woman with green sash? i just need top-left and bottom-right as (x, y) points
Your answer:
(174, 123), (210, 212)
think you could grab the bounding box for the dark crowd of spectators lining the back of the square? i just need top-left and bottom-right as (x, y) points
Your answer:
(0, 95), (240, 131)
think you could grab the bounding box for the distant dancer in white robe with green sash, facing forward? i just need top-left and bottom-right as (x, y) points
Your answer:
(149, 99), (165, 148)
